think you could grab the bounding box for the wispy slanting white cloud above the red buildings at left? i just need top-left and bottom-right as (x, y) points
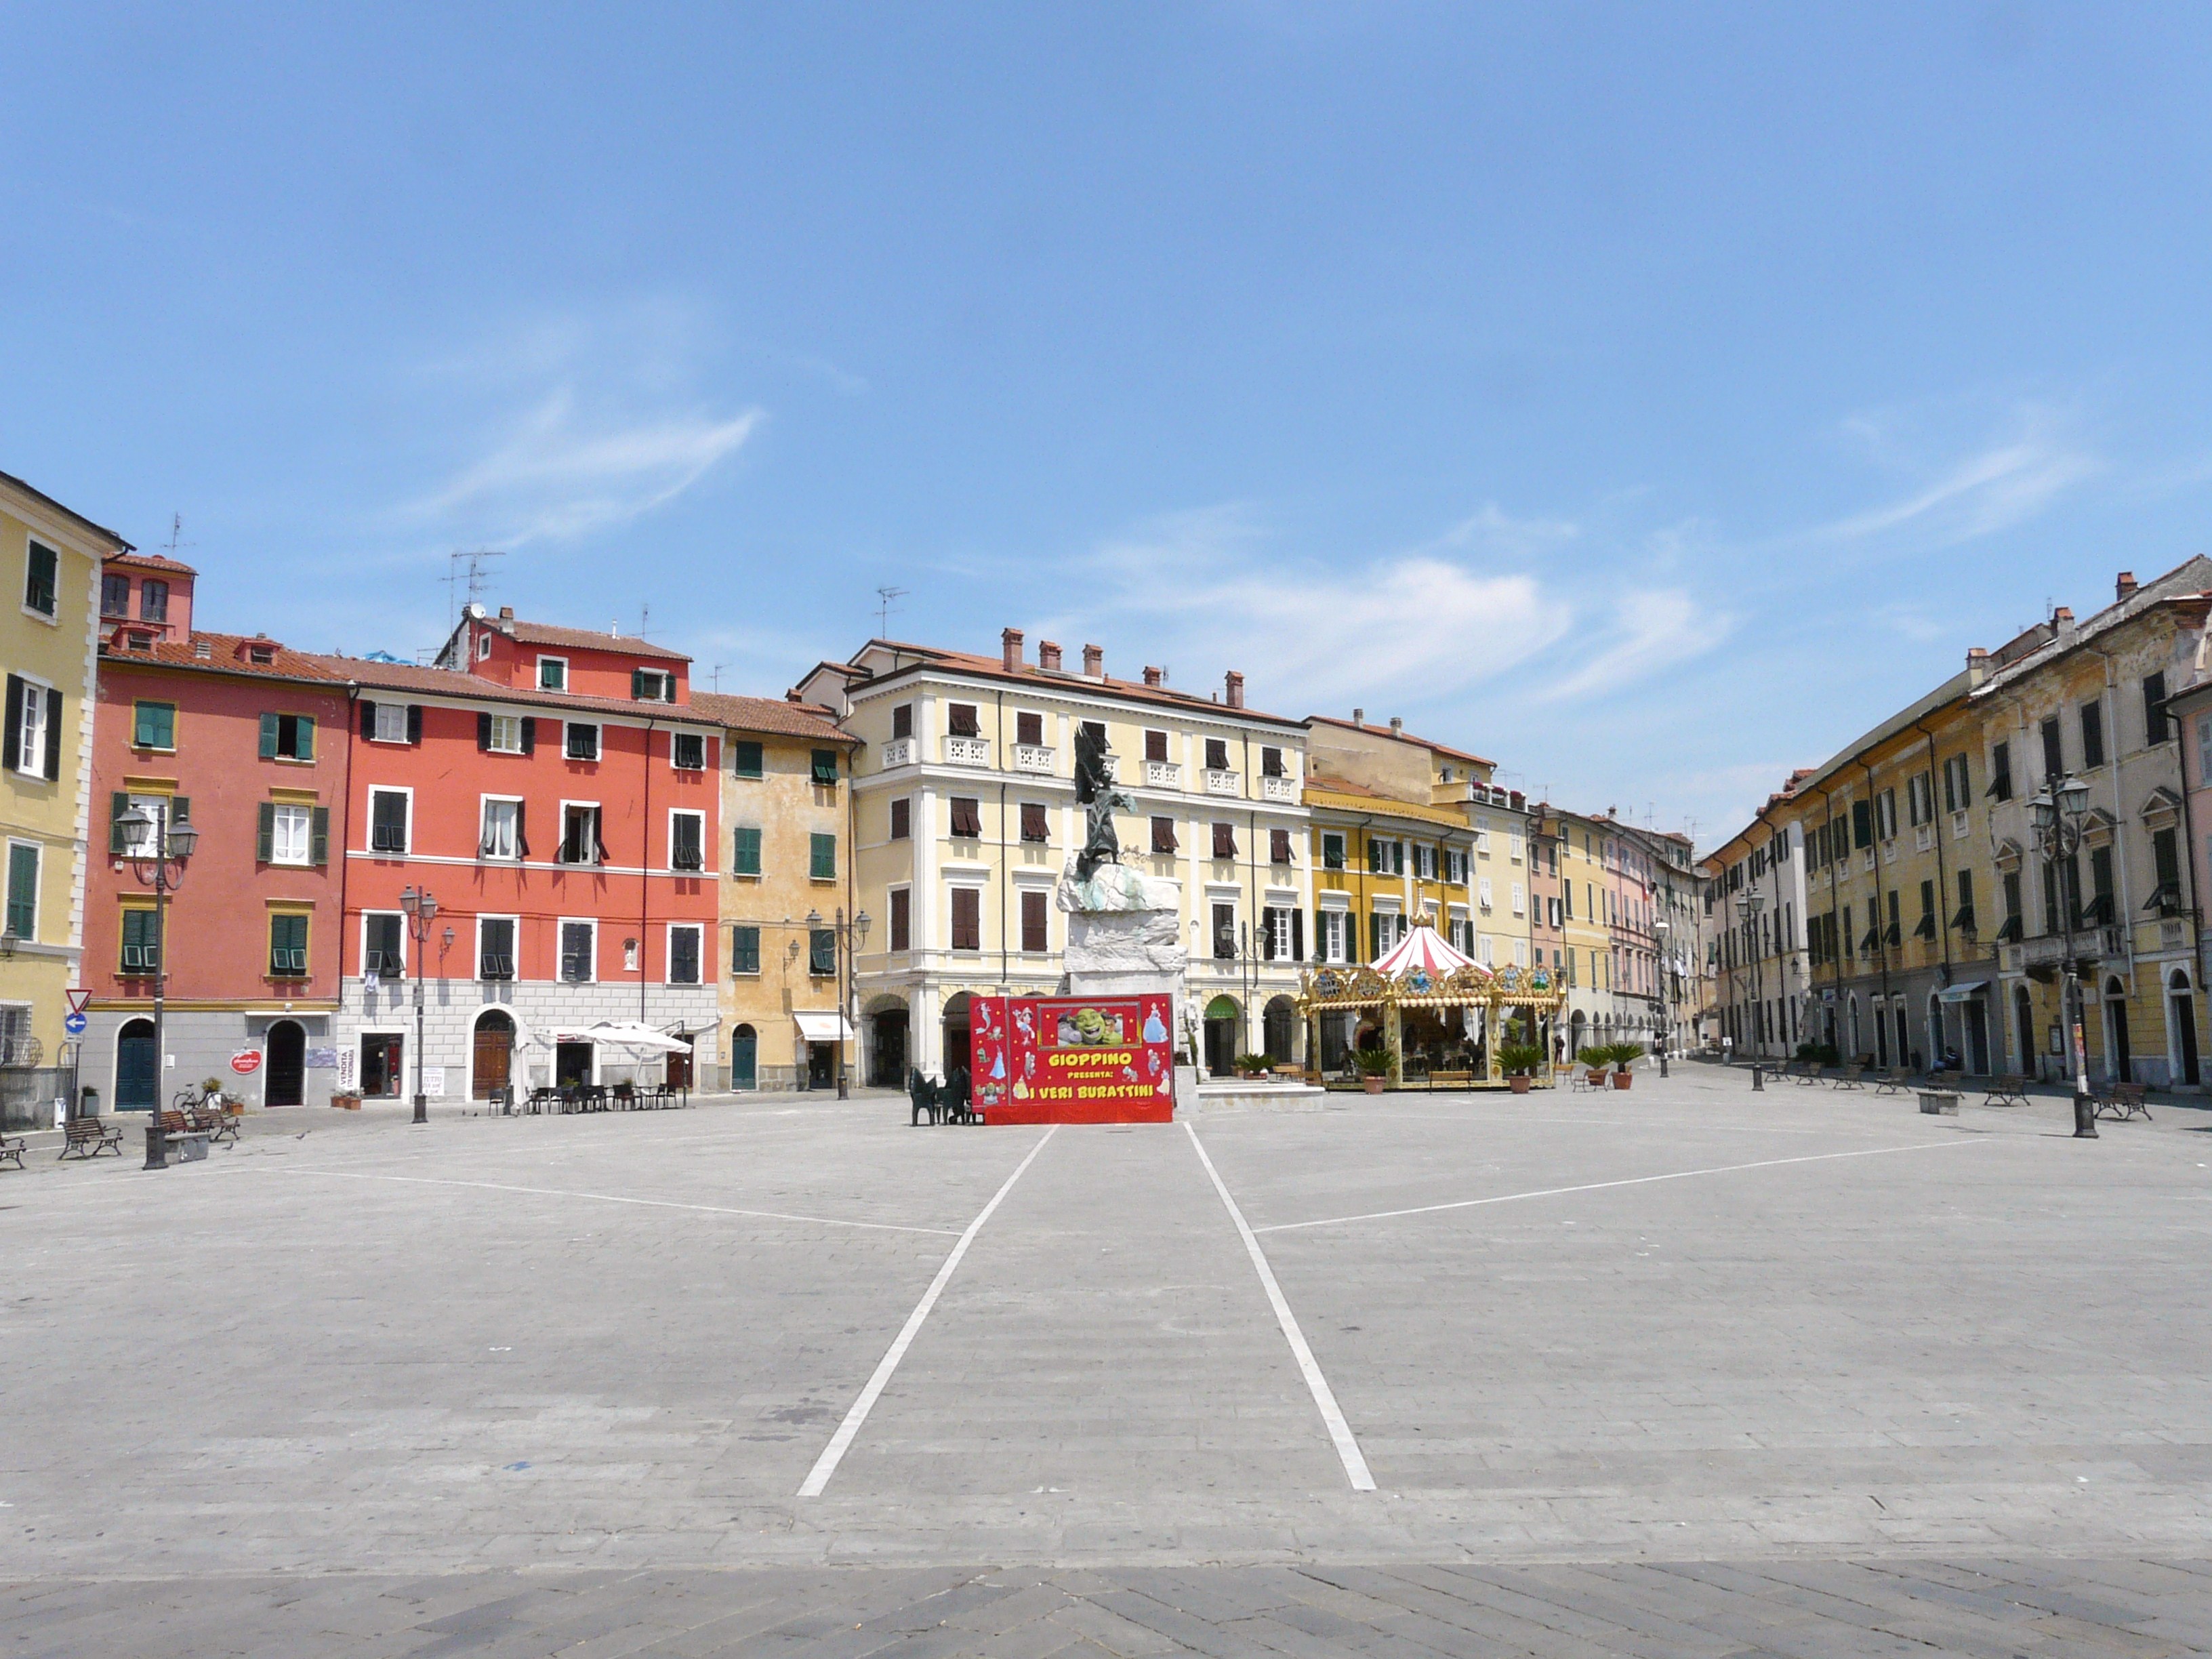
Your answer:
(413, 387), (765, 546)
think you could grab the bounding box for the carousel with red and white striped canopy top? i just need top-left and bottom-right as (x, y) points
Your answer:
(1298, 916), (1566, 1086)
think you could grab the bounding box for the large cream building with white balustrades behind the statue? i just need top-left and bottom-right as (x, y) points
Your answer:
(798, 628), (1312, 1080)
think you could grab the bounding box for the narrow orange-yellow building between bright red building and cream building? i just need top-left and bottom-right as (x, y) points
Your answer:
(690, 693), (858, 1090)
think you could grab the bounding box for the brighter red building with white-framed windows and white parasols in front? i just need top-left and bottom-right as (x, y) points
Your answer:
(325, 606), (721, 1099)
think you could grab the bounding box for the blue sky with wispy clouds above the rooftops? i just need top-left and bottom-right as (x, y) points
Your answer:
(0, 2), (2212, 840)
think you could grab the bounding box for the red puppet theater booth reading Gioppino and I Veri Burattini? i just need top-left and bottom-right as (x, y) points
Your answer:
(969, 991), (1174, 1124)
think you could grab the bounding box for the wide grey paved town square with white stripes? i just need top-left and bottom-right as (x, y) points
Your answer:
(0, 1062), (2212, 1654)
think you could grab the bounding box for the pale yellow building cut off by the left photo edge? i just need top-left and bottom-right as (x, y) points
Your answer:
(0, 473), (131, 1124)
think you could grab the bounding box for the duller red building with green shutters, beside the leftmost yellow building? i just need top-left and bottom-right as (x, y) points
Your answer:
(80, 555), (352, 1111)
